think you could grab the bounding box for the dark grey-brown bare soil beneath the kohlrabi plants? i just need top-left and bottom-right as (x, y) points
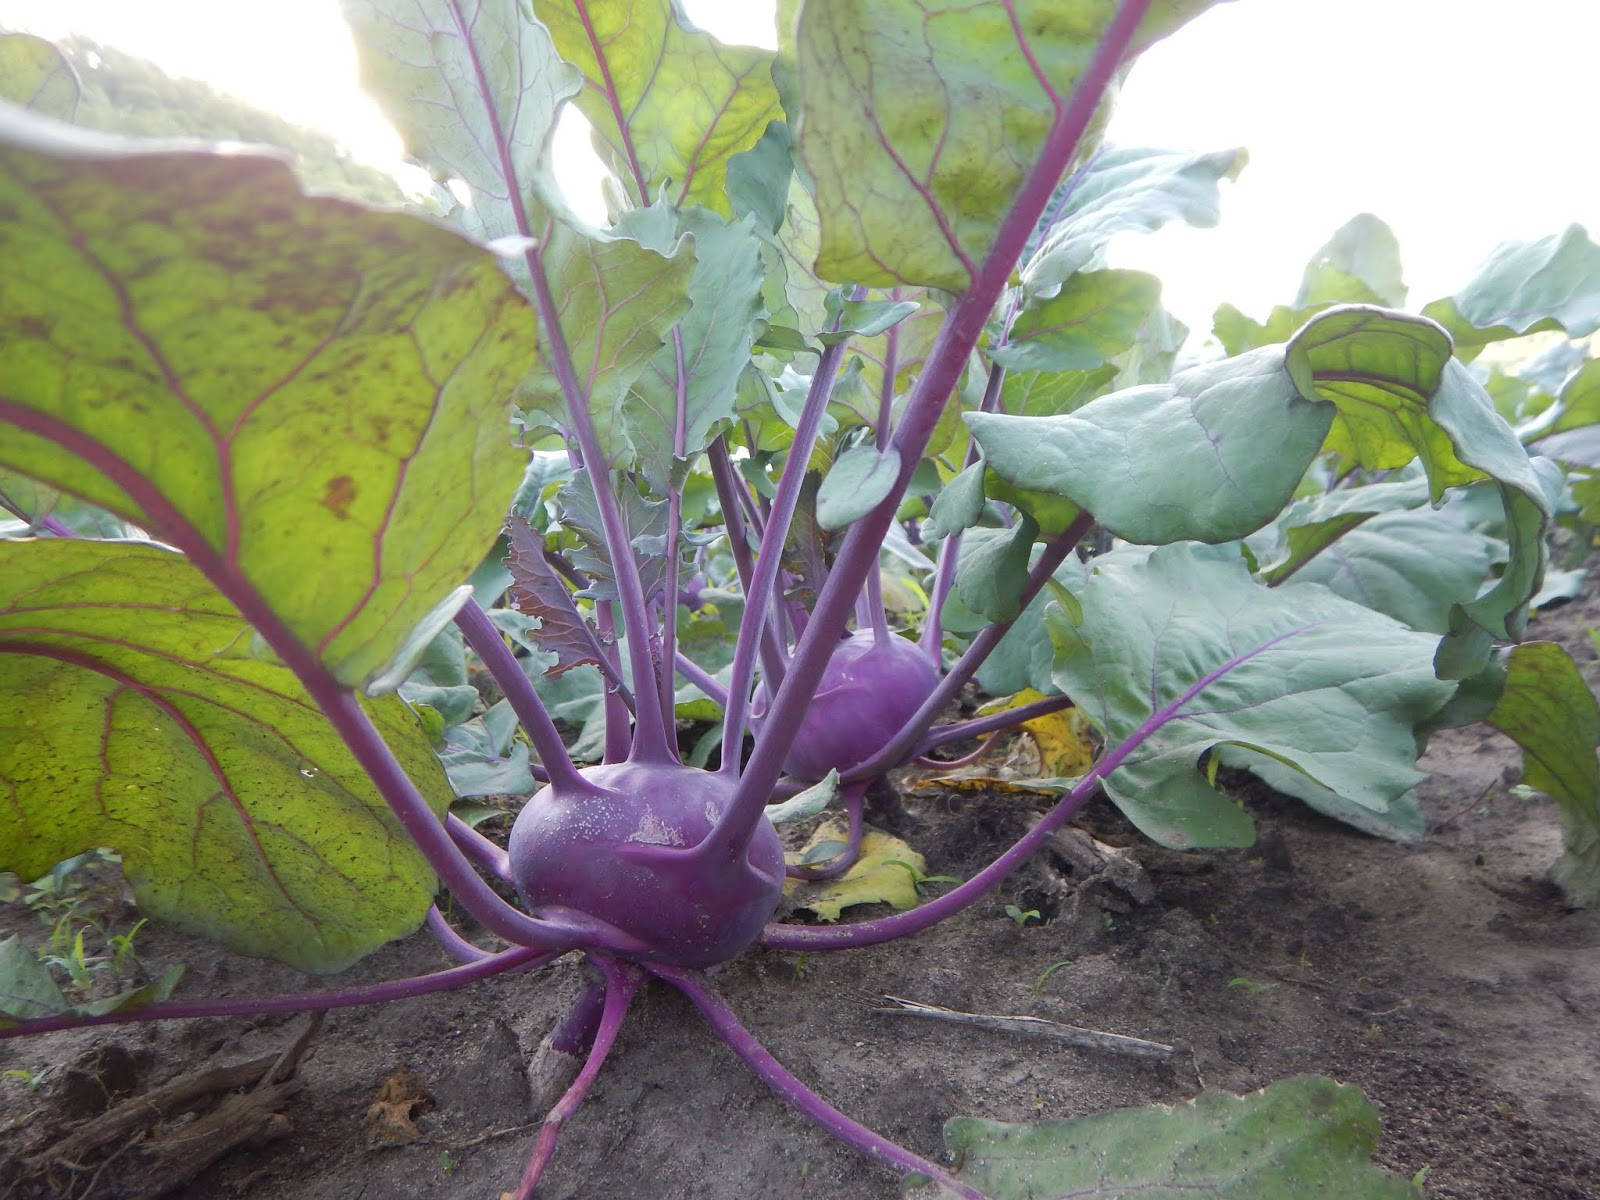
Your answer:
(0, 598), (1600, 1200)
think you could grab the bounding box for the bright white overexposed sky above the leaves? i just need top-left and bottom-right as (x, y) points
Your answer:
(0, 0), (1600, 342)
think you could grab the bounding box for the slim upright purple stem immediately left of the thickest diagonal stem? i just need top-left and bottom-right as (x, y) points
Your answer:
(718, 341), (861, 774)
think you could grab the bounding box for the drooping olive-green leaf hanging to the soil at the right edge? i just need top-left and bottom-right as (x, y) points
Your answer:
(1488, 642), (1600, 906)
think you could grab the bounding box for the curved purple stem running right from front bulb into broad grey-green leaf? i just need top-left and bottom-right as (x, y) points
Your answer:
(762, 626), (1310, 950)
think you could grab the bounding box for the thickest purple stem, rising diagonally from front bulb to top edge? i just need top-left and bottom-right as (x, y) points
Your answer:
(707, 0), (1150, 856)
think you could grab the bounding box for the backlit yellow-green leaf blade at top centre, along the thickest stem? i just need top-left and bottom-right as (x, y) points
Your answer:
(793, 0), (1210, 291)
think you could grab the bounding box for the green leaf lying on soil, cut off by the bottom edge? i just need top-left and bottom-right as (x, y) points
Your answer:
(944, 1075), (1421, 1200)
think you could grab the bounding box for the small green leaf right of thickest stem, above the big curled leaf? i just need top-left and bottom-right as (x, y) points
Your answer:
(989, 270), (1162, 371)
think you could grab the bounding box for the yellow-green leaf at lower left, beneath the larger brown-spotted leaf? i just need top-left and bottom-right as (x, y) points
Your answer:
(0, 539), (450, 971)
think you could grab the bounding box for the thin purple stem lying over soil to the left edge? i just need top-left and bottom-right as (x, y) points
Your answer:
(0, 946), (563, 1042)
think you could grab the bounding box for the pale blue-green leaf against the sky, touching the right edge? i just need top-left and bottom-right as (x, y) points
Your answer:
(1422, 226), (1600, 360)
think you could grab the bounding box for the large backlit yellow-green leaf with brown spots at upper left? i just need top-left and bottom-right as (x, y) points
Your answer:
(0, 120), (538, 685)
